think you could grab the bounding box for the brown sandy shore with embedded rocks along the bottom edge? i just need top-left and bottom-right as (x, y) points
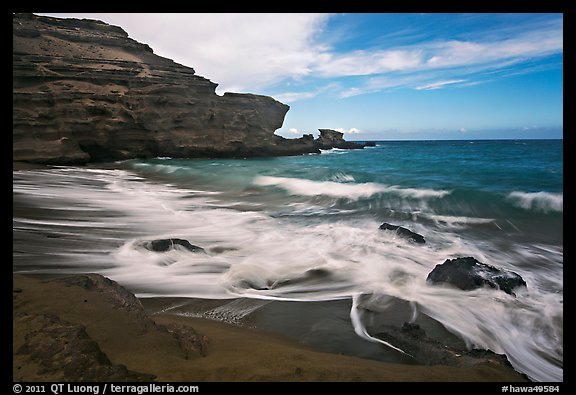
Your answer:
(13, 274), (526, 382)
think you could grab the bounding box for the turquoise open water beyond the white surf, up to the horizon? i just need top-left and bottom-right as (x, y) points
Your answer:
(126, 140), (563, 245)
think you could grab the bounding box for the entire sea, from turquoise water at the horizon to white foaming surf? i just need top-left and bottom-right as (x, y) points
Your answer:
(13, 140), (563, 381)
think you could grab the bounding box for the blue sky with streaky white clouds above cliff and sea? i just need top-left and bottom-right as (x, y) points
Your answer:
(41, 13), (563, 140)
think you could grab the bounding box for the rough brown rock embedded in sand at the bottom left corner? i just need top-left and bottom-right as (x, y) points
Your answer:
(13, 313), (155, 382)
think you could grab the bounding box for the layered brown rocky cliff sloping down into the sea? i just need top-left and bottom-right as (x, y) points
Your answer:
(12, 14), (362, 164)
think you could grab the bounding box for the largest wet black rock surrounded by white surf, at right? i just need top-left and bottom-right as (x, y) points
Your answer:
(426, 257), (526, 296)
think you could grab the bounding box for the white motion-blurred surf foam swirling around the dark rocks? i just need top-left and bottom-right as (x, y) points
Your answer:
(14, 169), (563, 381)
